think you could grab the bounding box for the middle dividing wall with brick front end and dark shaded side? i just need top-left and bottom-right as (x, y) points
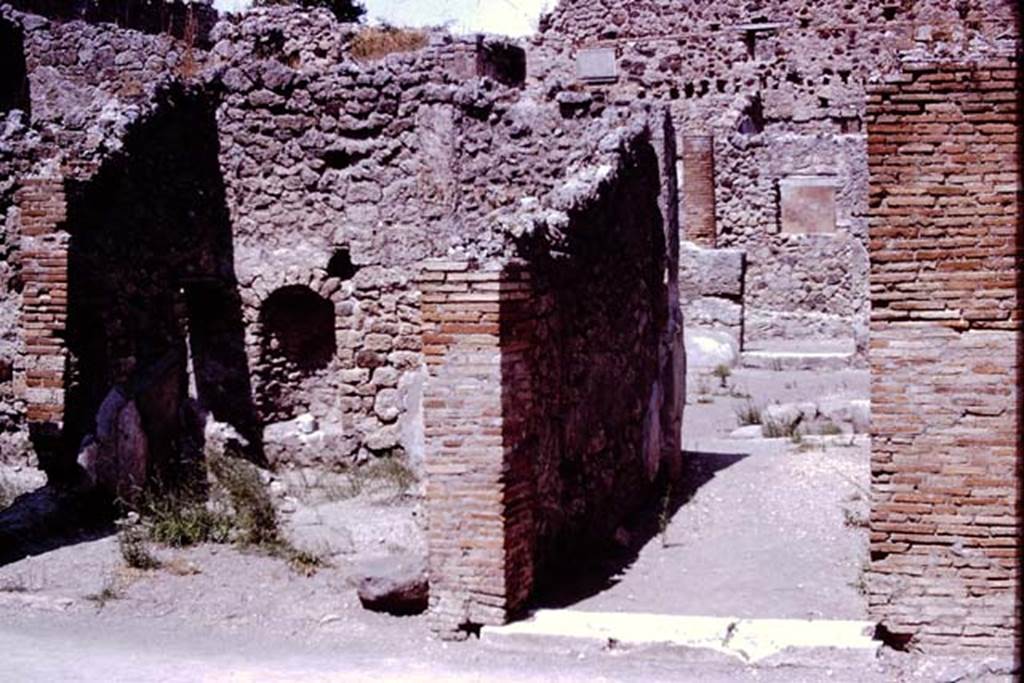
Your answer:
(421, 121), (684, 635)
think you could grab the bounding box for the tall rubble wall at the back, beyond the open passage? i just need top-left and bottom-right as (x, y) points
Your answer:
(530, 0), (1014, 350)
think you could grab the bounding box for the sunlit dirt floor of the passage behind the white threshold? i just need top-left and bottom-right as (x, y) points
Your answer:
(575, 370), (869, 620)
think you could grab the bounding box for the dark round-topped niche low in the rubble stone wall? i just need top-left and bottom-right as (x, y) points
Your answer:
(258, 285), (338, 421)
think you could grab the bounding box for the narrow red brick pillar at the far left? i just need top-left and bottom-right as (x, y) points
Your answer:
(15, 177), (68, 444)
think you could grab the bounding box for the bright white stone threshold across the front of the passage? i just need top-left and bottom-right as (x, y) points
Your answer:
(480, 609), (882, 668)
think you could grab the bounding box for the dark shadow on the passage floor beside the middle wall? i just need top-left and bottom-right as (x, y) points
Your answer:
(532, 451), (750, 609)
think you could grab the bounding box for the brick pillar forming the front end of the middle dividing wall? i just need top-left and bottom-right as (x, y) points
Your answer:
(420, 262), (534, 637)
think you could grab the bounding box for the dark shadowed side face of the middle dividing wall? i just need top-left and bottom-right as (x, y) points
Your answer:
(502, 136), (671, 606)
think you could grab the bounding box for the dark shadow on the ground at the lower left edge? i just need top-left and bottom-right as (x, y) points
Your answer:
(0, 485), (115, 566)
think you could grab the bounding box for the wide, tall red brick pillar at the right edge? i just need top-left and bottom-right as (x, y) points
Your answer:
(868, 59), (1021, 649)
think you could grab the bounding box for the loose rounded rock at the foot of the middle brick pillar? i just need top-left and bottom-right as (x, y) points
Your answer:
(355, 554), (430, 616)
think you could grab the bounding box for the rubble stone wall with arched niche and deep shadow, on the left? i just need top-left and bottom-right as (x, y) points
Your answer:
(5, 1), (674, 491)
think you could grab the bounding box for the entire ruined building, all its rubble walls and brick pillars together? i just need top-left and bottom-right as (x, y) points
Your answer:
(0, 0), (1020, 648)
